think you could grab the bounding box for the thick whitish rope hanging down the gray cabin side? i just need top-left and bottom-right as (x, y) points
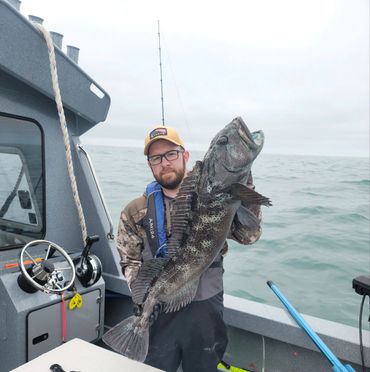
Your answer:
(34, 23), (87, 245)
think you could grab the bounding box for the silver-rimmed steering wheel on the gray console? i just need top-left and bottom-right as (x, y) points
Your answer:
(18, 240), (76, 294)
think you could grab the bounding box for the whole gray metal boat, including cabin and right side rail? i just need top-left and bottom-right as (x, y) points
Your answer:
(0, 0), (370, 372)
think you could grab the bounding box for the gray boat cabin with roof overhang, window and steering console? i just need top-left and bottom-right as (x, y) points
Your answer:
(0, 0), (127, 372)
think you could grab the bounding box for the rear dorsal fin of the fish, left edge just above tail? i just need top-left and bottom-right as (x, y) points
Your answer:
(131, 257), (169, 304)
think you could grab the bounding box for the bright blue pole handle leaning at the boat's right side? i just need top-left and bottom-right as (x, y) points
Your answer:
(267, 280), (355, 372)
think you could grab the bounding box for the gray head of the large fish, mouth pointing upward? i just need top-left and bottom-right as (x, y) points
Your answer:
(202, 117), (264, 192)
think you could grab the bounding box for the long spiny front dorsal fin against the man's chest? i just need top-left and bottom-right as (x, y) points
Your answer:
(167, 161), (202, 257)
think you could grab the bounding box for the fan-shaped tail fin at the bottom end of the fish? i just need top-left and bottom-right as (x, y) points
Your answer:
(103, 316), (149, 362)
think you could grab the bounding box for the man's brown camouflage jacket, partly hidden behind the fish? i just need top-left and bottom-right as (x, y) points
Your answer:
(117, 184), (262, 288)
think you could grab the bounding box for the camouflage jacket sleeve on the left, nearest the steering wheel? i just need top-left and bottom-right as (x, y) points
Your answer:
(117, 210), (144, 289)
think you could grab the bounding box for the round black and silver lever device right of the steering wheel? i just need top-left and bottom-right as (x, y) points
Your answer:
(74, 235), (102, 287)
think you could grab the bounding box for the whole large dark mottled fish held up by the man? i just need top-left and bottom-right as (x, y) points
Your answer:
(103, 117), (271, 361)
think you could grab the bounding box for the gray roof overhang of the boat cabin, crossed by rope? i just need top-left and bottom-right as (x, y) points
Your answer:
(0, 0), (110, 126)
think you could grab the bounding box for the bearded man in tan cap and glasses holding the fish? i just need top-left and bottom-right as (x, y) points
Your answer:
(117, 126), (261, 372)
